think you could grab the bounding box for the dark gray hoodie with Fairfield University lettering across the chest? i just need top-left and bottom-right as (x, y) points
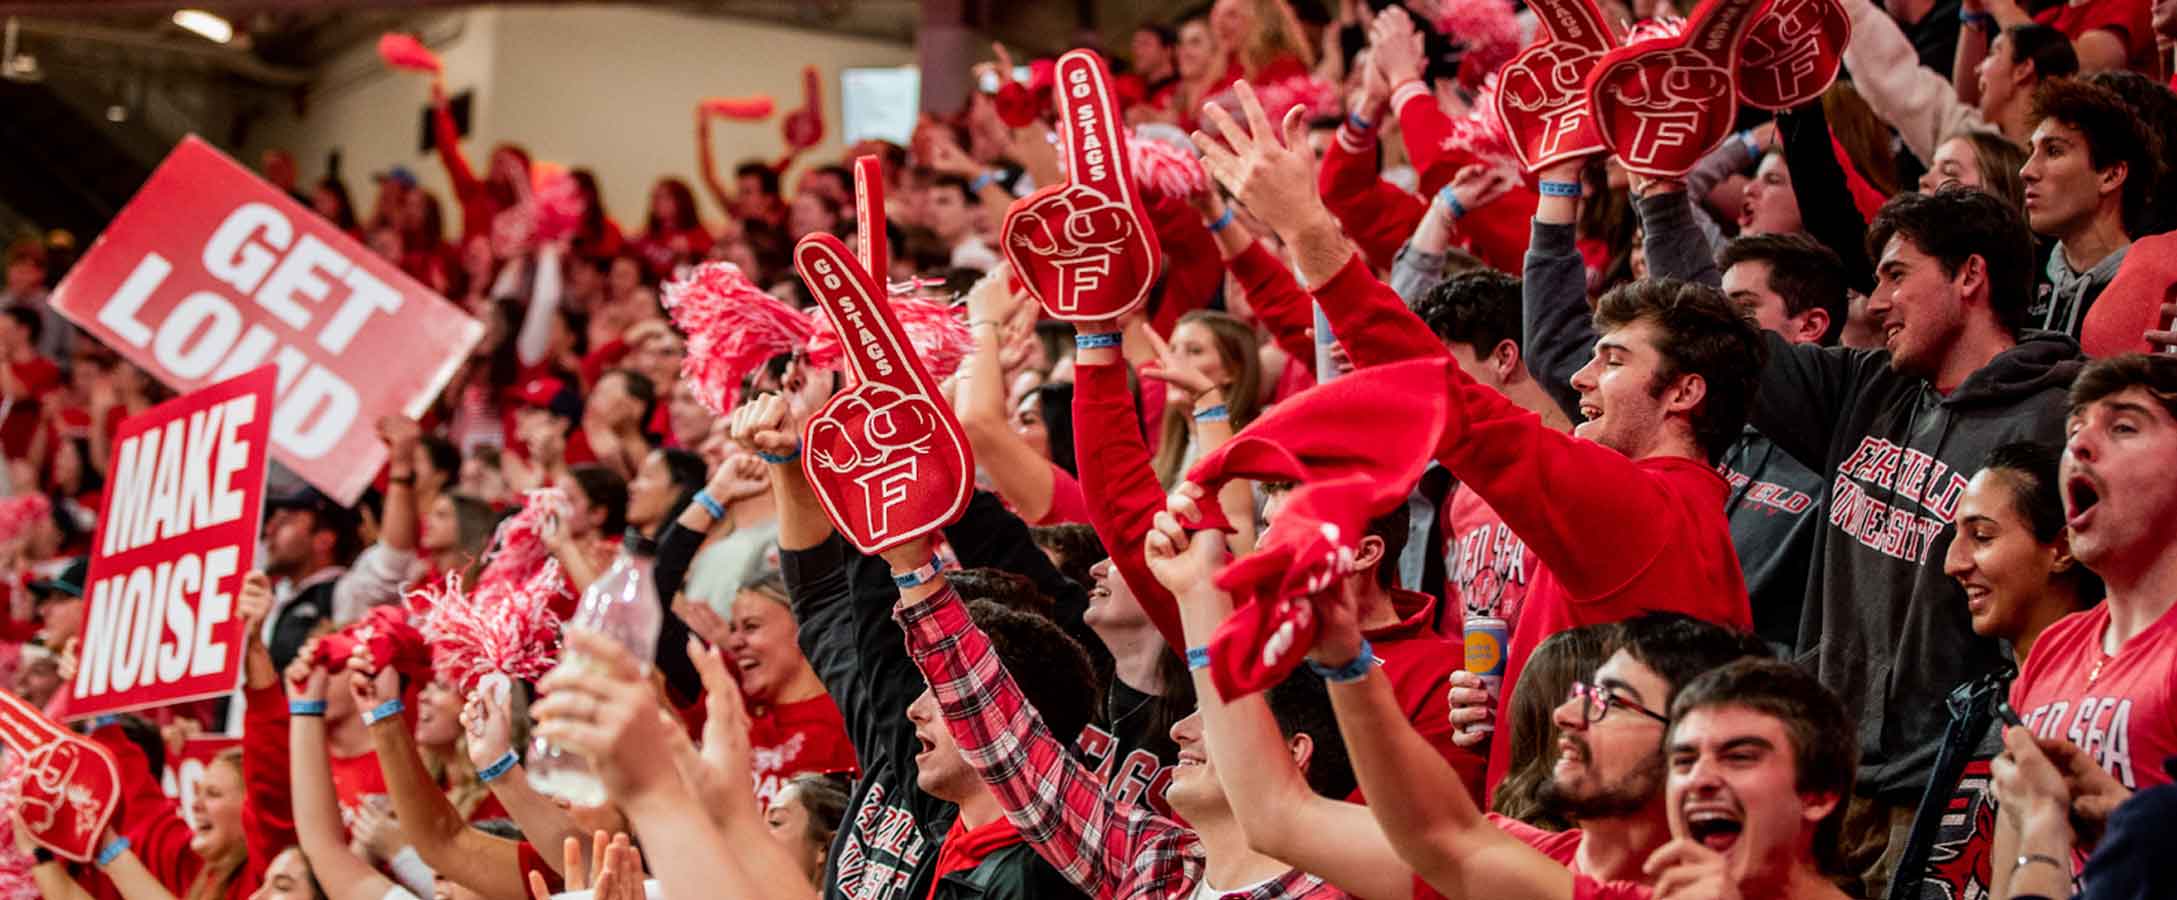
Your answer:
(1752, 331), (2081, 806)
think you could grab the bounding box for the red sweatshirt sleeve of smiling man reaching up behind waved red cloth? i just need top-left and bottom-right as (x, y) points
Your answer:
(1315, 257), (1678, 599)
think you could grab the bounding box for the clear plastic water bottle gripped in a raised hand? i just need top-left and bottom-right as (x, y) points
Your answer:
(525, 534), (664, 806)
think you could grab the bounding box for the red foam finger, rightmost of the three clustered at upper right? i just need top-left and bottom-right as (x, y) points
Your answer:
(1739, 0), (1853, 111)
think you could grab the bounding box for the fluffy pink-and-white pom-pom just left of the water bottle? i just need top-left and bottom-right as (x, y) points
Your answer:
(409, 560), (564, 693)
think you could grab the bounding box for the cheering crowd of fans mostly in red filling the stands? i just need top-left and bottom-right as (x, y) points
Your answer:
(0, 0), (2177, 900)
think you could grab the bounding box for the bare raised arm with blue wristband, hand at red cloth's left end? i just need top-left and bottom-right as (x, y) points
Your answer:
(1149, 514), (1413, 900)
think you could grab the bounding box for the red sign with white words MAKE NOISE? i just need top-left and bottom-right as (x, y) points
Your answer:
(67, 366), (279, 717)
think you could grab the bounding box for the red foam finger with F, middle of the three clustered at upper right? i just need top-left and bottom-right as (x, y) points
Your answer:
(1587, 0), (1770, 179)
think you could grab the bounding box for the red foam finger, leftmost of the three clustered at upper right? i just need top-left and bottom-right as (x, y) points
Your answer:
(1496, 0), (1618, 172)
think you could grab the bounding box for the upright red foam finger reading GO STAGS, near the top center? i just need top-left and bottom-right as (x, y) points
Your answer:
(1001, 50), (1163, 323)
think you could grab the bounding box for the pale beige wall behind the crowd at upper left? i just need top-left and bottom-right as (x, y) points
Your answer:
(244, 7), (914, 231)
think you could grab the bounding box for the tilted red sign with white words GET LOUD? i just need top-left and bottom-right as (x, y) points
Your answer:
(52, 137), (483, 503)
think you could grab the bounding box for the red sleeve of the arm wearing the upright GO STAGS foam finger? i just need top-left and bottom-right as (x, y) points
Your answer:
(1073, 362), (1186, 647)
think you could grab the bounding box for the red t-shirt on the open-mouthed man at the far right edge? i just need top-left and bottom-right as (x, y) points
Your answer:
(2012, 604), (2177, 791)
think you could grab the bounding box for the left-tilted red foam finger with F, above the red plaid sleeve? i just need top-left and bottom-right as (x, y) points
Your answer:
(795, 233), (975, 554)
